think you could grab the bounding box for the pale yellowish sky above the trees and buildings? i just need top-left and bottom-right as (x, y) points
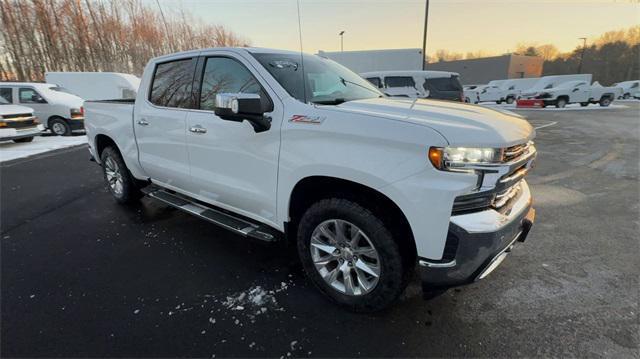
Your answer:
(155, 0), (640, 55)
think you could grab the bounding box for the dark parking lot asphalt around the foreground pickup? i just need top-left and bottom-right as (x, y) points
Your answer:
(0, 102), (640, 357)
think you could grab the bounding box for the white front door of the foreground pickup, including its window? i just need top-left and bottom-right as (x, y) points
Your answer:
(187, 52), (283, 223)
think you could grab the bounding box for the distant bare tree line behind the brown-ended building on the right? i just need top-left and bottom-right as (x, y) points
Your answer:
(429, 26), (640, 85)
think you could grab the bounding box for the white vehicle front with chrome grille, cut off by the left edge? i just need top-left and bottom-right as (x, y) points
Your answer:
(0, 95), (44, 142)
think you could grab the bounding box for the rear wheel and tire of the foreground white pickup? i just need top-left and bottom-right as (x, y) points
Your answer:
(100, 146), (142, 204)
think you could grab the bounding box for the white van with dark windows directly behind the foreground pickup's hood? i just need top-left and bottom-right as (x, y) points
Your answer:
(360, 71), (464, 101)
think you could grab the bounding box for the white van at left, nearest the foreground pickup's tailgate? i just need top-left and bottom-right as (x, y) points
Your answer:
(0, 82), (84, 136)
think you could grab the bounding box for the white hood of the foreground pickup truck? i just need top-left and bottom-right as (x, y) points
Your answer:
(337, 98), (535, 147)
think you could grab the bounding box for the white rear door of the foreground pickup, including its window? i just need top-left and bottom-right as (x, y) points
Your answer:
(133, 57), (197, 190)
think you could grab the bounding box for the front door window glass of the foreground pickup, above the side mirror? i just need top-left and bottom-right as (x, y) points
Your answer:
(200, 57), (265, 111)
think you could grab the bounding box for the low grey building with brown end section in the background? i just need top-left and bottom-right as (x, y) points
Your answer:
(426, 54), (544, 85)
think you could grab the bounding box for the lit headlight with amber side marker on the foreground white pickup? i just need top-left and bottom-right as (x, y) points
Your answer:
(429, 147), (502, 171)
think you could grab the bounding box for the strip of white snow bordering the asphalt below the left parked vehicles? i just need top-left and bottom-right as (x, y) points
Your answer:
(0, 135), (87, 162)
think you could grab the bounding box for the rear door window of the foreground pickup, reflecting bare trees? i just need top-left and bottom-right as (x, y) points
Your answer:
(149, 59), (193, 108)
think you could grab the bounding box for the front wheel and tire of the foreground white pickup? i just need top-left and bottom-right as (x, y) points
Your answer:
(297, 198), (415, 312)
